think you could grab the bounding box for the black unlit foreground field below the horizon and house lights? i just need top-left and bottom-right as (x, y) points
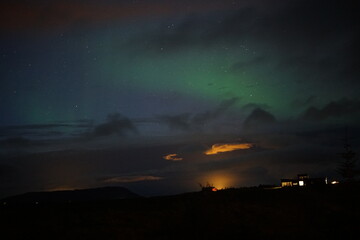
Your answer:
(0, 186), (360, 240)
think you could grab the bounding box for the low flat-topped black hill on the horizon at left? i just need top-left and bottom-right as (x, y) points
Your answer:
(2, 187), (140, 203)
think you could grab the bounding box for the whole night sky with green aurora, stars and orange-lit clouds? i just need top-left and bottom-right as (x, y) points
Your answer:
(0, 0), (360, 197)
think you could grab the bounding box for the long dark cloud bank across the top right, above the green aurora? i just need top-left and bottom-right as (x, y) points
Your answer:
(143, 0), (358, 47)
